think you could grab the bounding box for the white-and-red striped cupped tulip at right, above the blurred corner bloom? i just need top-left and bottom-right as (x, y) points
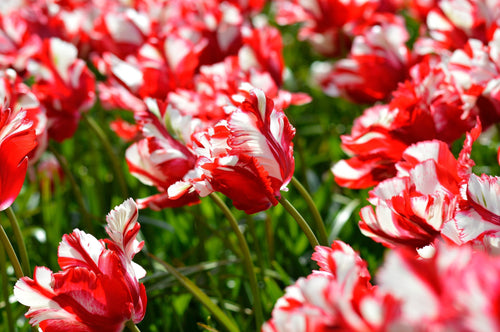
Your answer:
(359, 140), (460, 254)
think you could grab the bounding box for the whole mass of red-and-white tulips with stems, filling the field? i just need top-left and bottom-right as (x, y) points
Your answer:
(0, 0), (500, 332)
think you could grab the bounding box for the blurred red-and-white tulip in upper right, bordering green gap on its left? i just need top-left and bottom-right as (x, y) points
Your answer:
(312, 13), (411, 103)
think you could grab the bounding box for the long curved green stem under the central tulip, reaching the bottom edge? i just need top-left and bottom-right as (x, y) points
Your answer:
(209, 193), (264, 330)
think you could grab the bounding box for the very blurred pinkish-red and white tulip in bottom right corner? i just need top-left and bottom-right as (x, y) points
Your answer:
(376, 242), (500, 332)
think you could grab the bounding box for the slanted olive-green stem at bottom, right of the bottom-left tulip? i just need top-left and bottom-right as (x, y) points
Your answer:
(149, 254), (239, 332)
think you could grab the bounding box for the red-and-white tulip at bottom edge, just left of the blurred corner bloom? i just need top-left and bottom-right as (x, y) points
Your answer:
(262, 241), (397, 332)
